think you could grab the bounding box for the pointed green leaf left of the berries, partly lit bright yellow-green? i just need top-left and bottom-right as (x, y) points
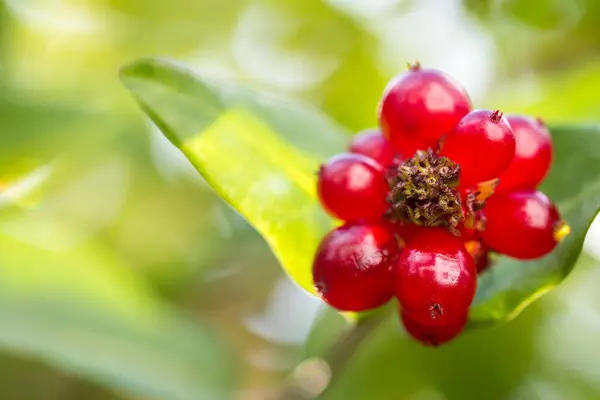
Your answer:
(121, 60), (347, 292)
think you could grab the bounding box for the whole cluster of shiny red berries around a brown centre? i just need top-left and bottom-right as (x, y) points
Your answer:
(313, 65), (569, 346)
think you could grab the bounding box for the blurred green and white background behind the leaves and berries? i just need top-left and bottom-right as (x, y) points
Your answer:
(0, 0), (600, 400)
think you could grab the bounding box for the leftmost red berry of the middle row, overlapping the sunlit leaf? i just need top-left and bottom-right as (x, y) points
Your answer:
(317, 153), (388, 221)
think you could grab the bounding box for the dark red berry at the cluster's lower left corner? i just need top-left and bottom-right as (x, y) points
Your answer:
(313, 224), (400, 311)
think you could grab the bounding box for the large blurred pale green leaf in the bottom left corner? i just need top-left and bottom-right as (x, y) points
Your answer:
(0, 231), (232, 400)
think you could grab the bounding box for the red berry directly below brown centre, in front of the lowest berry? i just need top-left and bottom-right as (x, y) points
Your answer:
(395, 228), (477, 327)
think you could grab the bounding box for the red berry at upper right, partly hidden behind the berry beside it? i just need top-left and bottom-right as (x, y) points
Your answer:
(496, 115), (553, 193)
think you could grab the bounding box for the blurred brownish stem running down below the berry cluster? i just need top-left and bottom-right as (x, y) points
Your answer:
(278, 312), (386, 400)
